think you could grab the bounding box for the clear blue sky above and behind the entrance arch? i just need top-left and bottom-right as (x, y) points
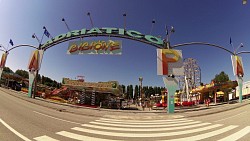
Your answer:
(0, 0), (250, 86)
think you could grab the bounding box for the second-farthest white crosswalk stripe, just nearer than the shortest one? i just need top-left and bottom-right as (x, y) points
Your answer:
(95, 120), (193, 125)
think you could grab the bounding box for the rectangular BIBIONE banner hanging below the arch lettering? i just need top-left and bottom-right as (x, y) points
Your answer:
(67, 40), (122, 55)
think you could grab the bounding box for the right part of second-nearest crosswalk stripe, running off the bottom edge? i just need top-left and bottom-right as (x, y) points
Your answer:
(159, 125), (238, 141)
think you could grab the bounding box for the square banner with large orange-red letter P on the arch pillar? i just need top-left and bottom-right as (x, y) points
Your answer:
(157, 49), (184, 76)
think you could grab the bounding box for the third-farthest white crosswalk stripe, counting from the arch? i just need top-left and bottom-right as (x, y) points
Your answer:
(89, 121), (201, 128)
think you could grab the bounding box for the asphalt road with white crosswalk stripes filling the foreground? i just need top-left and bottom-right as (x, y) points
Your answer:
(0, 88), (250, 141)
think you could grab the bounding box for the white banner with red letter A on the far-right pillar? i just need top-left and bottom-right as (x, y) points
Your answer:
(231, 55), (244, 77)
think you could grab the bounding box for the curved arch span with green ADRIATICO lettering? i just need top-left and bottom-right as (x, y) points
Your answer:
(40, 27), (164, 50)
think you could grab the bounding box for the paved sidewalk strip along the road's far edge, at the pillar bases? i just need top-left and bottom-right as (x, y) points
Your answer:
(0, 87), (250, 119)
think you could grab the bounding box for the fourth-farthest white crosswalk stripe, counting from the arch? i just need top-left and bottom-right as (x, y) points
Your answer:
(82, 123), (211, 132)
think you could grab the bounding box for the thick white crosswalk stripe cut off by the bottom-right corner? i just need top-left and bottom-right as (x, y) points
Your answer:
(219, 126), (250, 141)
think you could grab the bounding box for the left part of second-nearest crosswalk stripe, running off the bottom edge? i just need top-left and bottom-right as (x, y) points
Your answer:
(56, 131), (123, 141)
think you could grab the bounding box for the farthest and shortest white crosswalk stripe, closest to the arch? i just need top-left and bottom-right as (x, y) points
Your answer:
(99, 118), (188, 123)
